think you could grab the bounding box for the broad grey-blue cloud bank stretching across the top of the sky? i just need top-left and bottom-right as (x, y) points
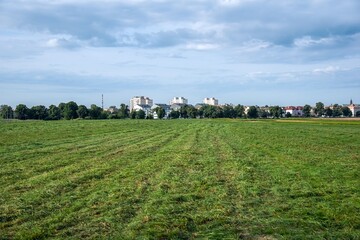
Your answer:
(0, 0), (360, 52)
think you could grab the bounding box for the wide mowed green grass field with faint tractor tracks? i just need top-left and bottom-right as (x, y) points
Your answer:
(0, 120), (360, 239)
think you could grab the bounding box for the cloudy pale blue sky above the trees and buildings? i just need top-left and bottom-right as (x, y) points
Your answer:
(0, 0), (360, 107)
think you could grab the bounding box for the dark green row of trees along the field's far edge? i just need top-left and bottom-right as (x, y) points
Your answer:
(0, 101), (360, 120)
